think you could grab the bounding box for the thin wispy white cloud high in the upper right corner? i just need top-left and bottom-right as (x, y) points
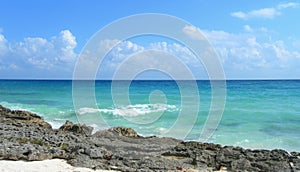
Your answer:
(231, 2), (298, 20)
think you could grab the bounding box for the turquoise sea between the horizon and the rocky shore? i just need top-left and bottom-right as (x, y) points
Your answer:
(0, 80), (300, 151)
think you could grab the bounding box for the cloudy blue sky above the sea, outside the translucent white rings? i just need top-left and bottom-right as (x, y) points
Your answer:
(0, 0), (300, 79)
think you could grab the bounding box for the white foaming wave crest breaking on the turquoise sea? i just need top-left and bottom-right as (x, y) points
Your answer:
(77, 104), (179, 117)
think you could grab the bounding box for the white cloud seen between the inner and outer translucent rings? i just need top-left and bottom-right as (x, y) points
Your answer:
(98, 40), (204, 79)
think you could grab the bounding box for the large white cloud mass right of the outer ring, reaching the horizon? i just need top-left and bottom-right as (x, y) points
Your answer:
(183, 23), (300, 78)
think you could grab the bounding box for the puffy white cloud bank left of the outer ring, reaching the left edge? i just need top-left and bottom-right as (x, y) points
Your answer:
(0, 30), (77, 77)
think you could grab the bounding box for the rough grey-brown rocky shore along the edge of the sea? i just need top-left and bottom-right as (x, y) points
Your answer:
(0, 105), (300, 171)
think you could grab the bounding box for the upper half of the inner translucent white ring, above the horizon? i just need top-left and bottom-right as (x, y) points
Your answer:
(110, 49), (199, 80)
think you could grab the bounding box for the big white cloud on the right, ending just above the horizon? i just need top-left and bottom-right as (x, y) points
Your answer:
(203, 27), (300, 74)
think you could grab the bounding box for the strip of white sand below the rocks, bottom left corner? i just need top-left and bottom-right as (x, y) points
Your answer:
(0, 159), (116, 172)
